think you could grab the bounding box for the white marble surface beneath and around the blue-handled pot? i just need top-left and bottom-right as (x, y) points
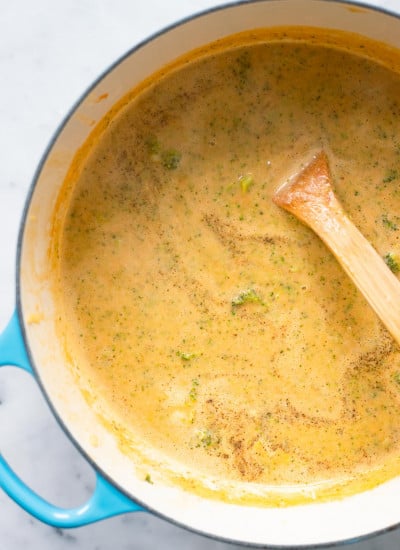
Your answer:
(0, 0), (400, 550)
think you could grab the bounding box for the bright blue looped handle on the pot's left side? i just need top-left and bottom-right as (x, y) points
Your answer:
(0, 312), (143, 528)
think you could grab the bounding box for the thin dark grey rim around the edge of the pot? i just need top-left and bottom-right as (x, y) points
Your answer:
(15, 0), (400, 550)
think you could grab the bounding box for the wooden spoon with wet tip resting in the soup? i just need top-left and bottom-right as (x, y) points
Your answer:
(273, 152), (400, 344)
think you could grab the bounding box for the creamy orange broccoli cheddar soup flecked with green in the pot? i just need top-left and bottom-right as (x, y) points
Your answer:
(54, 28), (400, 505)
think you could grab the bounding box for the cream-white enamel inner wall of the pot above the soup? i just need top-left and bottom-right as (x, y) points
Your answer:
(18, 0), (400, 547)
